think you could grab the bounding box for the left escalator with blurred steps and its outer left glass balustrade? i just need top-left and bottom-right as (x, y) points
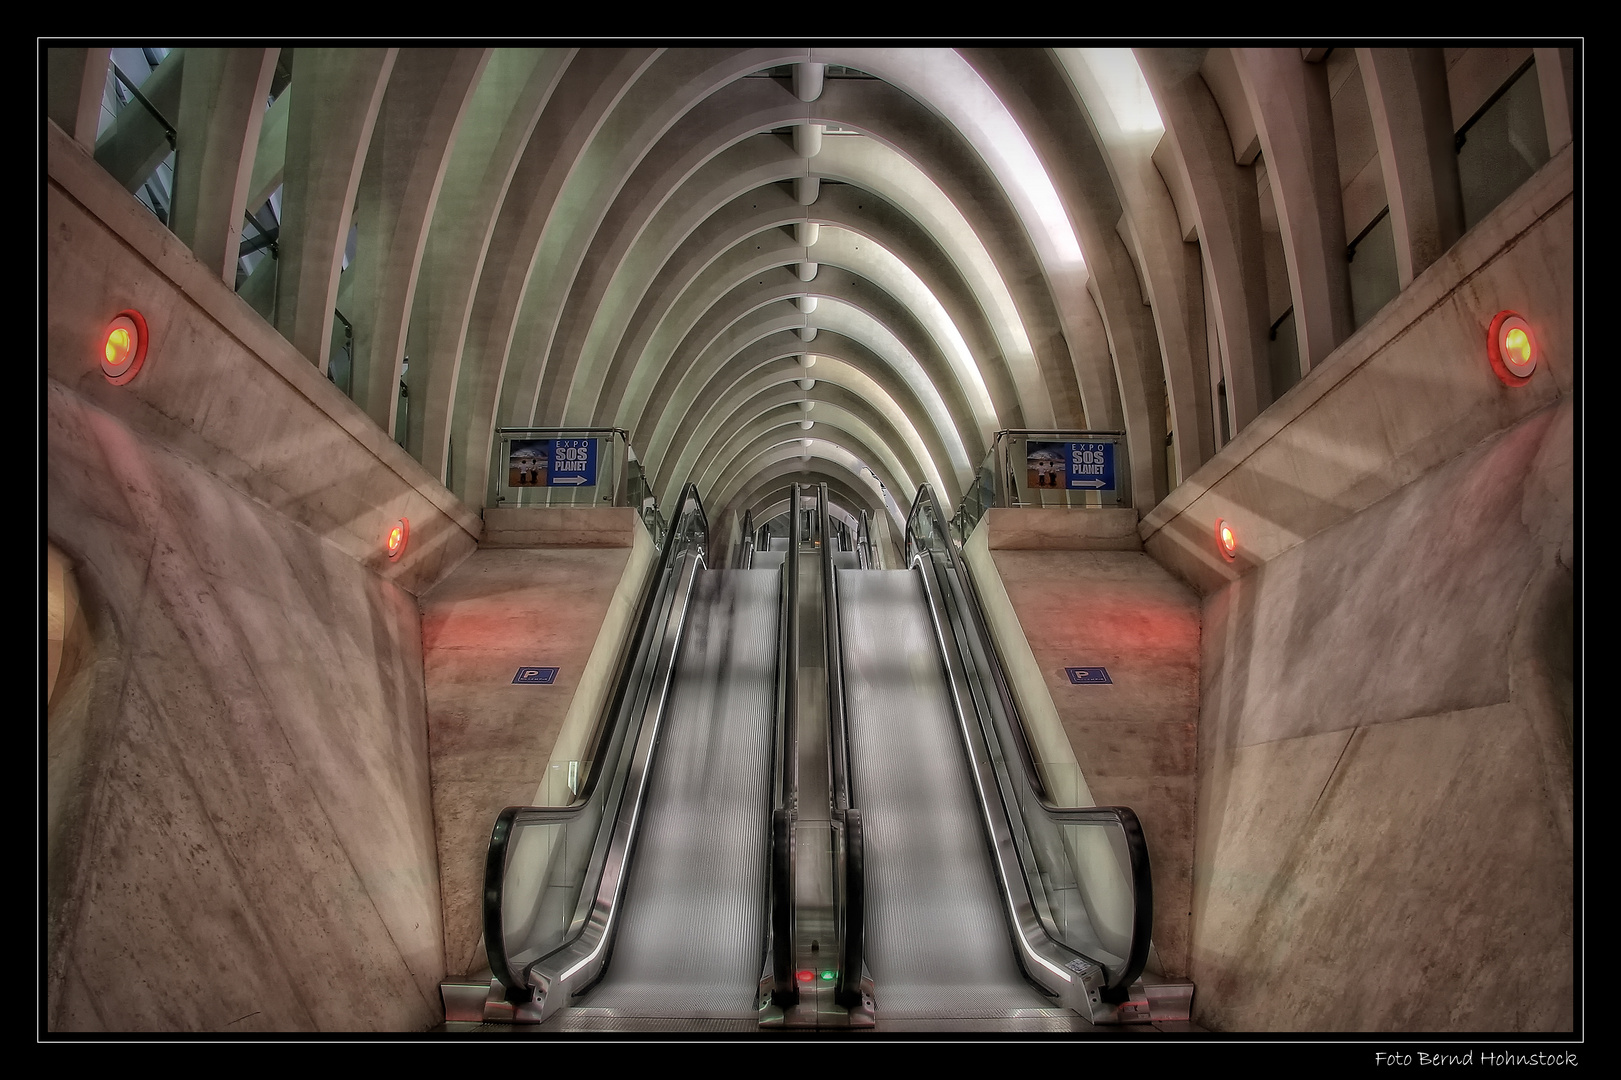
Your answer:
(483, 488), (785, 1031)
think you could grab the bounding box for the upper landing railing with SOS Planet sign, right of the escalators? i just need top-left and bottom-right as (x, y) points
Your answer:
(950, 428), (1131, 546)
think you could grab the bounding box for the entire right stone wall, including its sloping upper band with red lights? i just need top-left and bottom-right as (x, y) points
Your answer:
(1141, 142), (1580, 1031)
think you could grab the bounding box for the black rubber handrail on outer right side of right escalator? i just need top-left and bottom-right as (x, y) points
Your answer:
(906, 483), (1153, 1001)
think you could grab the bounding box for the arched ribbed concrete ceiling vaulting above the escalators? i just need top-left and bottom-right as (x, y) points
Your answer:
(128, 45), (1334, 525)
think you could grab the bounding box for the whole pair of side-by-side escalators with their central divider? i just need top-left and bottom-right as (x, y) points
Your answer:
(463, 485), (1191, 1031)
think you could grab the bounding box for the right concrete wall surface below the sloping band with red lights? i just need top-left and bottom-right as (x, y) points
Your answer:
(1191, 397), (1574, 1031)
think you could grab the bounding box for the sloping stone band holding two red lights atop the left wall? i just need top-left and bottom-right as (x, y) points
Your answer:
(44, 125), (481, 594)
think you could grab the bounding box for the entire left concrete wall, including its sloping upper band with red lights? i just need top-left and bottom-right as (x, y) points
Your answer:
(42, 123), (481, 1031)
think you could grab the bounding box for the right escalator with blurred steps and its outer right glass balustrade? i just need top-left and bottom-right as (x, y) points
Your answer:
(828, 486), (1191, 1031)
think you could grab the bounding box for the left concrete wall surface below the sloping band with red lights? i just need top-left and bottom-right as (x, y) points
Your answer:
(45, 381), (444, 1031)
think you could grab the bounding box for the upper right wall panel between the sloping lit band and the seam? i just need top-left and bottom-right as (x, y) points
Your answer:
(1206, 397), (1569, 744)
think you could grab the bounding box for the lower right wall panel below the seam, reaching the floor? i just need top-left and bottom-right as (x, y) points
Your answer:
(1191, 705), (1574, 1033)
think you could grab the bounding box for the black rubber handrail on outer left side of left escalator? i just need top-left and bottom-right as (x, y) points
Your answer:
(483, 483), (708, 1004)
